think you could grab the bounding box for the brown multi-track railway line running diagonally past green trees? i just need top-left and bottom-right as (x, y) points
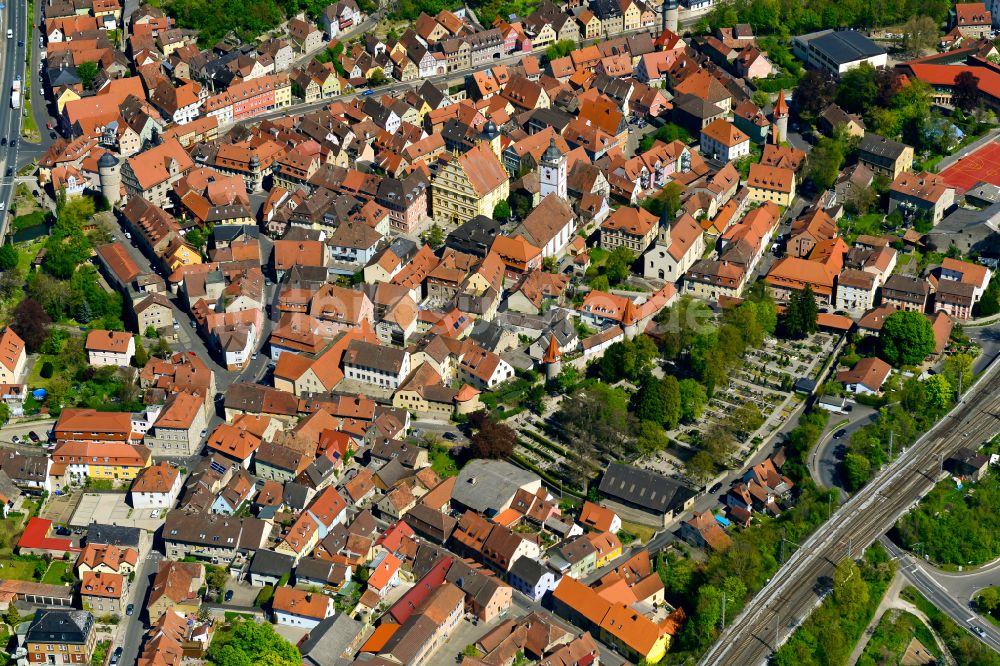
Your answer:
(701, 359), (1000, 666)
